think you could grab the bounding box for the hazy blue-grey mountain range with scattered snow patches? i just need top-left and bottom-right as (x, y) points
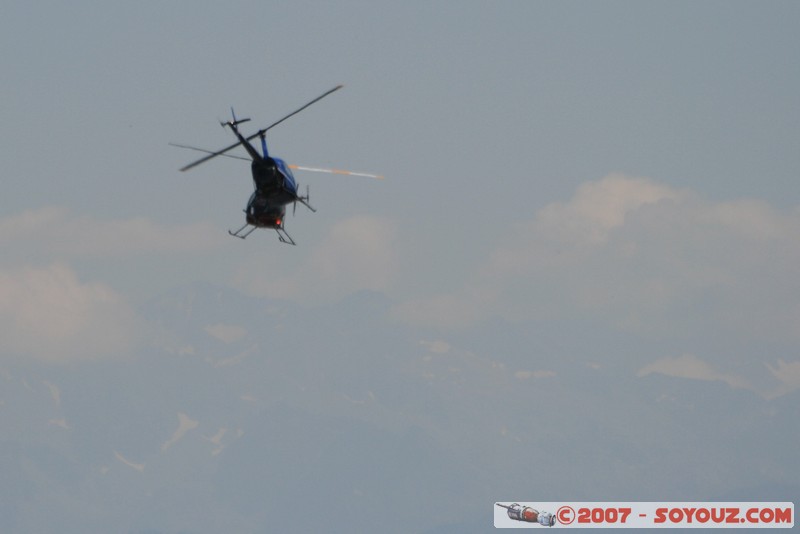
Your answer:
(0, 284), (800, 532)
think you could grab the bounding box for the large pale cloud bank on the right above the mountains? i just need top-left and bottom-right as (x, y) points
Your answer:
(396, 175), (800, 342)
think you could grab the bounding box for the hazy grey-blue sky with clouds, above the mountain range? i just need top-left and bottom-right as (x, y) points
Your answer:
(0, 1), (800, 532)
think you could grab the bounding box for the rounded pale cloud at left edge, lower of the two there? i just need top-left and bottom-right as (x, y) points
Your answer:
(0, 263), (138, 364)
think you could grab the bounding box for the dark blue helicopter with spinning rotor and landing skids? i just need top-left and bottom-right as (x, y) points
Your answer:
(170, 85), (383, 245)
